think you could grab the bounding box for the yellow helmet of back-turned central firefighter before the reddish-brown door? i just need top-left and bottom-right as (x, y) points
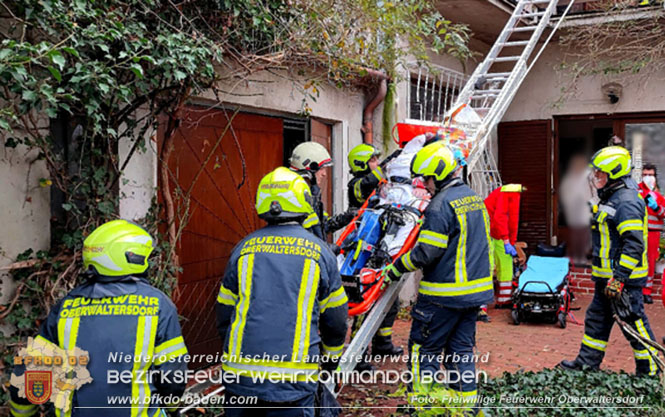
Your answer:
(256, 167), (313, 220)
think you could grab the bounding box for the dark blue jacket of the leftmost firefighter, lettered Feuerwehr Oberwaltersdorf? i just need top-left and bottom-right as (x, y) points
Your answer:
(10, 276), (187, 417)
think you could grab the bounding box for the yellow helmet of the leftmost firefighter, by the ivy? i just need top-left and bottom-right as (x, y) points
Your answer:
(83, 220), (153, 277)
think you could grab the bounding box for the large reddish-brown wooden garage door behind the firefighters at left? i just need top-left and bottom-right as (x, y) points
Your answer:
(168, 108), (283, 360)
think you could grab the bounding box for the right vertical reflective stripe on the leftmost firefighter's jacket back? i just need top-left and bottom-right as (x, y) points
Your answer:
(131, 316), (159, 417)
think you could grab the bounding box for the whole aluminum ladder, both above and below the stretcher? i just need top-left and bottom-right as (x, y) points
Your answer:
(327, 0), (574, 395)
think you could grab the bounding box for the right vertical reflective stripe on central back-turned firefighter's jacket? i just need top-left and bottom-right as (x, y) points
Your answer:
(291, 258), (320, 362)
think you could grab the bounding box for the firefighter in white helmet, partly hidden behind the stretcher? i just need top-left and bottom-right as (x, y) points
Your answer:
(289, 142), (356, 240)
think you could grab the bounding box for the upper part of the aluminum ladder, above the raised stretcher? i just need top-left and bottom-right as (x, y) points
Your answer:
(452, 0), (574, 198)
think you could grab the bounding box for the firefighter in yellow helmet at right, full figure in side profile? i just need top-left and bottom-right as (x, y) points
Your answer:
(559, 146), (657, 375)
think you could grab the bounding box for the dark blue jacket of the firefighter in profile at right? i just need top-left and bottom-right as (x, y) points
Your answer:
(591, 176), (649, 286)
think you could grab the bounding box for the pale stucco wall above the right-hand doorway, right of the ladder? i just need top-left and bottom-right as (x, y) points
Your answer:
(503, 44), (665, 121)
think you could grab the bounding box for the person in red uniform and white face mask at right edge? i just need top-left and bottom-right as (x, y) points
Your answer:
(639, 164), (665, 304)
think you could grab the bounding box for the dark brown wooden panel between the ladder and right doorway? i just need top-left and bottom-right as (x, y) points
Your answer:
(499, 120), (552, 253)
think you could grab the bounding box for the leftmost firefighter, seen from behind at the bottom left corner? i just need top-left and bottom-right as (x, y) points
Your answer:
(10, 220), (187, 417)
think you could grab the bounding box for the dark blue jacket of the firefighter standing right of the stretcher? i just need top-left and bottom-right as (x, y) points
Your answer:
(395, 178), (494, 308)
